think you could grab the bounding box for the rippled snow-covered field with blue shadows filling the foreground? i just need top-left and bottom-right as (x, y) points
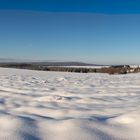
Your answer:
(0, 68), (140, 140)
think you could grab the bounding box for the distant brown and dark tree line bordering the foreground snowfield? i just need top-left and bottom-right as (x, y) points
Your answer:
(0, 63), (140, 74)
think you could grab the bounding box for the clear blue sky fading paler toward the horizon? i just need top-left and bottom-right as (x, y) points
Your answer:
(0, 0), (140, 64)
